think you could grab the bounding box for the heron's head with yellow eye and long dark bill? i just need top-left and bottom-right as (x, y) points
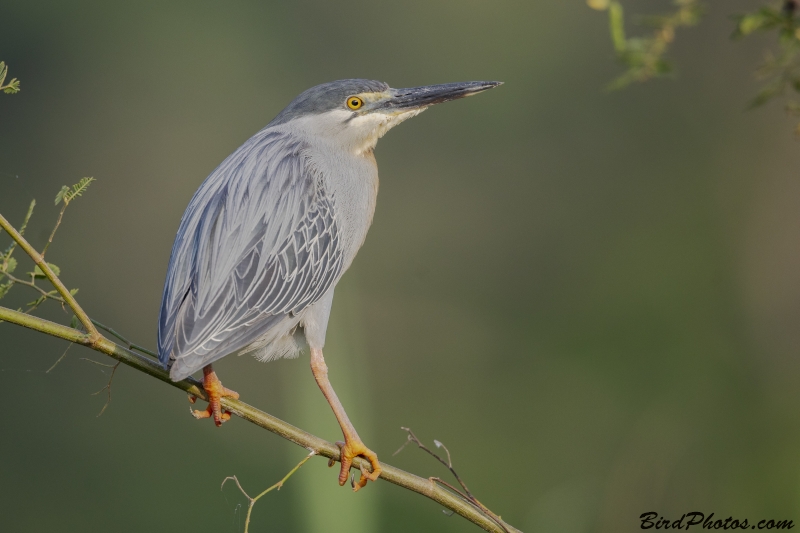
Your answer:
(268, 79), (502, 153)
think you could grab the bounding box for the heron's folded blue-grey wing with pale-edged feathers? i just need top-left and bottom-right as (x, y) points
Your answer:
(158, 129), (343, 375)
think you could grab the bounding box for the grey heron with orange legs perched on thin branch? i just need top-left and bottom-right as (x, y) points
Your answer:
(158, 79), (500, 490)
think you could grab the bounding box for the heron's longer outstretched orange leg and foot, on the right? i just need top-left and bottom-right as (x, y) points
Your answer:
(311, 348), (381, 491)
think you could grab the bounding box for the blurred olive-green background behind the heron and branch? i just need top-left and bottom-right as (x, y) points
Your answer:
(0, 0), (800, 533)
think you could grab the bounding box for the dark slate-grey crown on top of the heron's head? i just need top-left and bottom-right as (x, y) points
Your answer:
(269, 79), (389, 126)
